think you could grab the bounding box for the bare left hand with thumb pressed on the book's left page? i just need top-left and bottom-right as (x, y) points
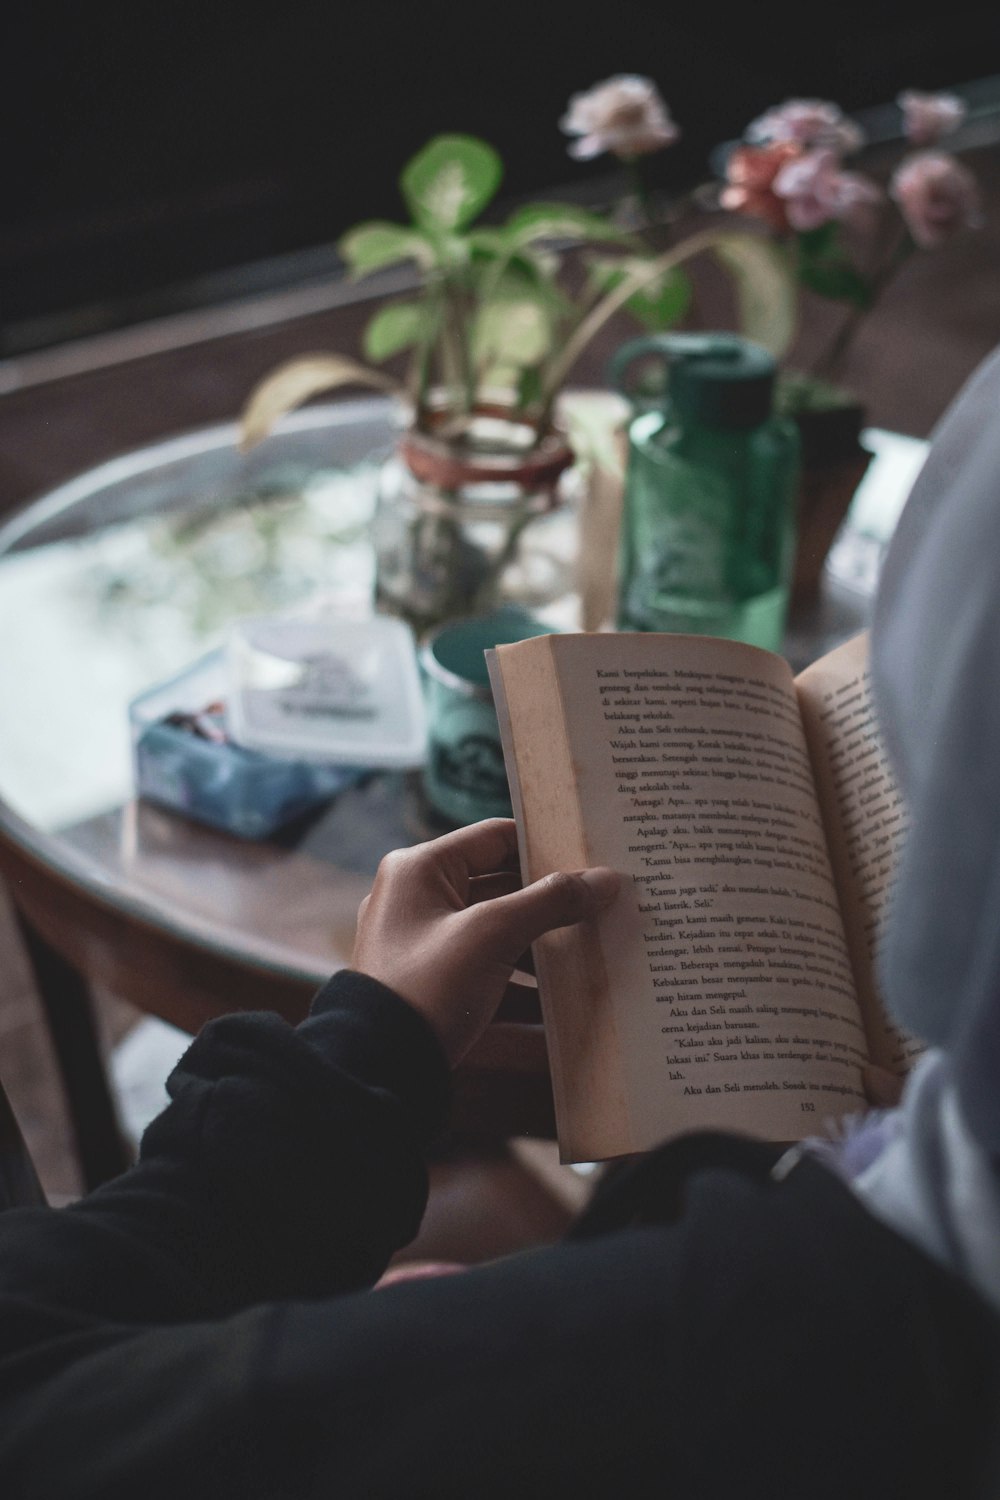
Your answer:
(351, 818), (621, 1067)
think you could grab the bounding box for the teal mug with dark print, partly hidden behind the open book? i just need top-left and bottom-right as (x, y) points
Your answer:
(420, 605), (550, 824)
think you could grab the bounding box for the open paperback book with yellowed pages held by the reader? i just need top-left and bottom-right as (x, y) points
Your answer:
(489, 633), (916, 1161)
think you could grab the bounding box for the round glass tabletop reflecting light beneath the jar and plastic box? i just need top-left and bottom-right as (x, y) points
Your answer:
(0, 398), (574, 983)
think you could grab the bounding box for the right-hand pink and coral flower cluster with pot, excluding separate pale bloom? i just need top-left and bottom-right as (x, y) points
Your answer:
(718, 90), (982, 599)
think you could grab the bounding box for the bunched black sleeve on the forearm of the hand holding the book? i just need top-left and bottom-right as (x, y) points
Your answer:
(0, 975), (448, 1323)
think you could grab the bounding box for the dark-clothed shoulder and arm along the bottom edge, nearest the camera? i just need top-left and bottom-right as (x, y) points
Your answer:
(0, 1143), (999, 1500)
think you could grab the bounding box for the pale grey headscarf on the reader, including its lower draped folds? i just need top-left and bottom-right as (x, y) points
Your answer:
(839, 351), (1000, 1307)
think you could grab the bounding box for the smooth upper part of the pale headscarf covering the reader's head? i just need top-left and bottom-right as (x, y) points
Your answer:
(871, 351), (1000, 1146)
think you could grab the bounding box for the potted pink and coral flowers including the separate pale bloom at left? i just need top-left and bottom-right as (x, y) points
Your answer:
(561, 75), (982, 600)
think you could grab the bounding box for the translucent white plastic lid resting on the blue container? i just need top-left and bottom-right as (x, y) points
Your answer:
(226, 615), (426, 770)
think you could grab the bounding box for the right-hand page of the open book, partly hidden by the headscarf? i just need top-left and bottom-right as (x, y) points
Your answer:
(796, 633), (922, 1073)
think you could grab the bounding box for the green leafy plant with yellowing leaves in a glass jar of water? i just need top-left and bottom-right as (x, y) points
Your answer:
(243, 135), (793, 632)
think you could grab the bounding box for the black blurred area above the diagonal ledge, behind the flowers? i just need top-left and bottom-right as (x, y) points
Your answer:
(7, 0), (1000, 354)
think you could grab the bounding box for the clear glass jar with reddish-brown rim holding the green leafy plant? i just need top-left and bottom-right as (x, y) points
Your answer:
(373, 405), (573, 635)
